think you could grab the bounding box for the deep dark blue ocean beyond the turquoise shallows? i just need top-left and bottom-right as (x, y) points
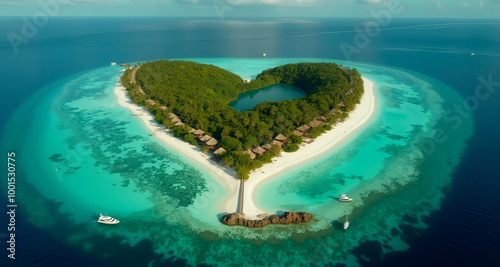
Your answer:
(0, 17), (500, 266)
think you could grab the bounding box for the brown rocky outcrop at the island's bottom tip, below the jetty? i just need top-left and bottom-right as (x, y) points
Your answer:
(221, 211), (312, 228)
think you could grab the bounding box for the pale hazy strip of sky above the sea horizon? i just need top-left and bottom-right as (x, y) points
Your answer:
(0, 0), (500, 19)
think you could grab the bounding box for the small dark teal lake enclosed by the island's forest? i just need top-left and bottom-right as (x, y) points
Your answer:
(228, 83), (306, 111)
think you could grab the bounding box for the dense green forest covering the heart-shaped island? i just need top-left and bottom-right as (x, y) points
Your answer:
(122, 60), (363, 179)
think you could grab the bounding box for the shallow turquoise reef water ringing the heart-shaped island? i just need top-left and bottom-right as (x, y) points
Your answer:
(8, 58), (472, 265)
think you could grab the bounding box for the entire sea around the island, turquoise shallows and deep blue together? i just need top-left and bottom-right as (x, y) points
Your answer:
(0, 18), (500, 266)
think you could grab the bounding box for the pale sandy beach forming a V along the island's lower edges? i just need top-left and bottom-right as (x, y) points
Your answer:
(114, 78), (375, 219)
